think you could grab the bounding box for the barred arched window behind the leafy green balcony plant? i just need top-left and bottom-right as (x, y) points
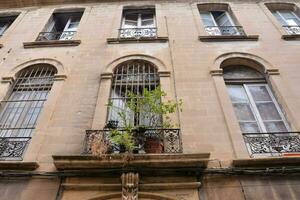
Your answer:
(108, 60), (161, 127)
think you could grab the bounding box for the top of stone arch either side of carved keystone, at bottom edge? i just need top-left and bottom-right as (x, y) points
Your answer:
(87, 192), (177, 200)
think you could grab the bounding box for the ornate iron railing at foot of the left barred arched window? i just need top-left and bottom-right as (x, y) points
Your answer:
(0, 137), (31, 160)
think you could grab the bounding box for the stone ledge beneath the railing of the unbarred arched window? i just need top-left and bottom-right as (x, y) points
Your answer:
(232, 156), (300, 167)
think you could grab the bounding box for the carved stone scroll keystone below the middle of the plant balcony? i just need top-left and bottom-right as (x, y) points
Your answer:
(121, 172), (139, 200)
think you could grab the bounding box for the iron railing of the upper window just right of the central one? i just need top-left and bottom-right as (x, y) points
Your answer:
(205, 26), (246, 36)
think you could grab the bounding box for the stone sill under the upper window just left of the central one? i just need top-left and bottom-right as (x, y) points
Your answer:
(23, 40), (81, 49)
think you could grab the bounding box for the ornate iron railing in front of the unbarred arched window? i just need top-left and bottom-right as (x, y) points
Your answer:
(243, 132), (300, 157)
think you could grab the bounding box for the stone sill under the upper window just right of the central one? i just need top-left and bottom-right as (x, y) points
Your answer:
(199, 35), (259, 42)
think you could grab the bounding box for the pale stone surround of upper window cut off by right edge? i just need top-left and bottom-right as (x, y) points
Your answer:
(258, 0), (299, 35)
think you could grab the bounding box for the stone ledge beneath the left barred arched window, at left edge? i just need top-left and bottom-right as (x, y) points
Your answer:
(0, 161), (39, 171)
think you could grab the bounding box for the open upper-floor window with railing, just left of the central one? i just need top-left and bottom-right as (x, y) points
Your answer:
(36, 12), (83, 41)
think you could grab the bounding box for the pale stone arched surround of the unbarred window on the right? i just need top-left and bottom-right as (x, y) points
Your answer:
(210, 52), (300, 158)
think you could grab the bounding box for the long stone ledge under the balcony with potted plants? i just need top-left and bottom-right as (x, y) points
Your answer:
(52, 153), (210, 170)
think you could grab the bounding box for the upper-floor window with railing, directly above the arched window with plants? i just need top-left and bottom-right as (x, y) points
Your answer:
(119, 9), (156, 38)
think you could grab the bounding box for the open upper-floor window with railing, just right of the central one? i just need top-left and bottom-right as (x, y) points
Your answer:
(198, 4), (245, 35)
